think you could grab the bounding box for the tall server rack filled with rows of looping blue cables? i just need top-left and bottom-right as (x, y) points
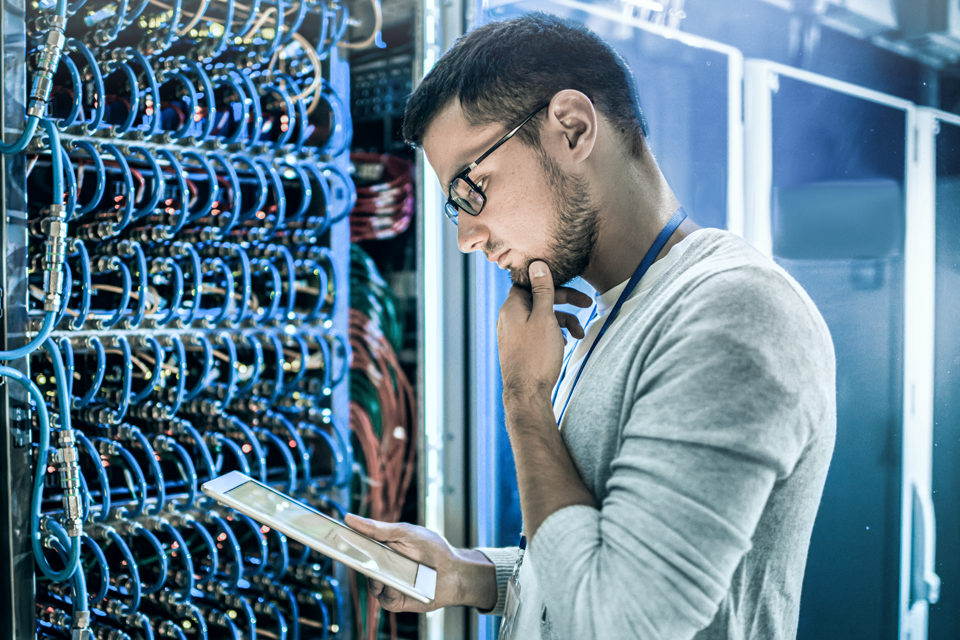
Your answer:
(0, 0), (355, 640)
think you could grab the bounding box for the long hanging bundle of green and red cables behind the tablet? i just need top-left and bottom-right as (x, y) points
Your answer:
(350, 245), (417, 640)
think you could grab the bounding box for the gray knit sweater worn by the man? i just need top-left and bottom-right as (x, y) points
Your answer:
(481, 230), (836, 640)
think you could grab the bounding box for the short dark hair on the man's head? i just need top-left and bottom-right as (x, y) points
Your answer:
(403, 12), (647, 156)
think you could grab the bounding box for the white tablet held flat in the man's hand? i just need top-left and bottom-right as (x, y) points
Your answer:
(202, 471), (437, 604)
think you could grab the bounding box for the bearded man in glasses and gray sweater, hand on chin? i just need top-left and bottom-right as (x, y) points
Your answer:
(347, 14), (836, 640)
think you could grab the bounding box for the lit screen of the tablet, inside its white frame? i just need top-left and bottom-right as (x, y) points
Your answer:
(226, 481), (419, 588)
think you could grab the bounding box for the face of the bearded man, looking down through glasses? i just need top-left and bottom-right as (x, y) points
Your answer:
(423, 100), (597, 288)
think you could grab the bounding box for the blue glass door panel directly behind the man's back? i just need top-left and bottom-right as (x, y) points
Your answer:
(770, 74), (907, 640)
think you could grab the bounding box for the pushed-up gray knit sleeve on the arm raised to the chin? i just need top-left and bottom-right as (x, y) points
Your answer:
(530, 270), (832, 640)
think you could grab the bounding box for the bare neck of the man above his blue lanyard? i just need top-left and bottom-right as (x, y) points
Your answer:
(582, 144), (699, 293)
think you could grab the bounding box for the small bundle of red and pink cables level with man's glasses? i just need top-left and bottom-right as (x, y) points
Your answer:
(350, 153), (415, 242)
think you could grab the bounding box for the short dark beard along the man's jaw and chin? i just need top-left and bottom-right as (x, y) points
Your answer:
(510, 149), (600, 290)
